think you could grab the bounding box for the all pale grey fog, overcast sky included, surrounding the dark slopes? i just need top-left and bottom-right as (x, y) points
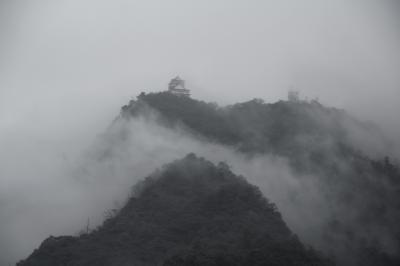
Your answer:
(0, 0), (400, 264)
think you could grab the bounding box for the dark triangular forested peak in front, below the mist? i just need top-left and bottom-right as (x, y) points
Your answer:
(17, 154), (331, 266)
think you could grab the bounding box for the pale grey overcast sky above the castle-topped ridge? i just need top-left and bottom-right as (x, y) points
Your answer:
(0, 0), (400, 265)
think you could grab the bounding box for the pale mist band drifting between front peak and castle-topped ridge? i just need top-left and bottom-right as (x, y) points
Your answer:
(0, 106), (392, 265)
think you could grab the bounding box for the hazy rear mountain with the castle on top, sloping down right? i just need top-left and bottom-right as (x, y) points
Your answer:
(120, 92), (400, 265)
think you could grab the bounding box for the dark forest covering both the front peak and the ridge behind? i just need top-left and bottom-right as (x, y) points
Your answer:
(19, 92), (400, 266)
